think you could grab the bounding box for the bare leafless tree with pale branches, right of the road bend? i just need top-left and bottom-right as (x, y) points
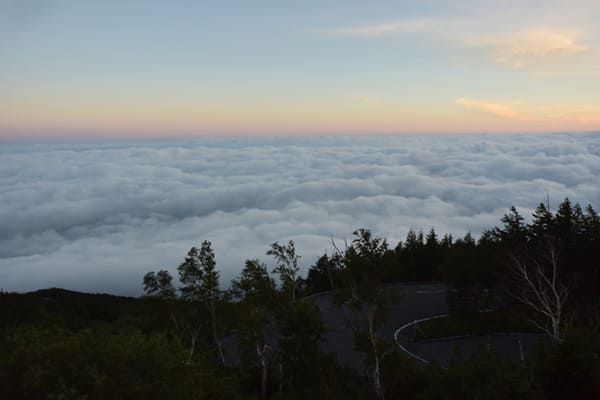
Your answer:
(507, 240), (575, 342)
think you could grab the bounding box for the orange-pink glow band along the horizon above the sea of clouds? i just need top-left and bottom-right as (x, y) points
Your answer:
(0, 97), (600, 138)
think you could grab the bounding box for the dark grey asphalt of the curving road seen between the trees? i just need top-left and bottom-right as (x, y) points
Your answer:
(224, 282), (547, 373)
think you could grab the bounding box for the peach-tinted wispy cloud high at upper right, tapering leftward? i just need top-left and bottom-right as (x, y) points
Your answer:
(323, 16), (600, 74)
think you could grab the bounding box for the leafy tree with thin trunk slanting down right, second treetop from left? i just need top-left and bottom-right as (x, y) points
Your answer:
(177, 240), (225, 365)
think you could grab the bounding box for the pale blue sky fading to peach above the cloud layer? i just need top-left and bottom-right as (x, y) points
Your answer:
(0, 0), (600, 139)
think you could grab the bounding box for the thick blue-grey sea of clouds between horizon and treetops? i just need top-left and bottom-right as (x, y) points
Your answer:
(0, 133), (600, 295)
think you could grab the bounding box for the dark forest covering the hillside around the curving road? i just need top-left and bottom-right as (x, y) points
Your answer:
(0, 199), (600, 400)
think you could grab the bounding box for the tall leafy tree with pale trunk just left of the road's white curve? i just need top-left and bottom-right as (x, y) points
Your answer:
(334, 229), (398, 400)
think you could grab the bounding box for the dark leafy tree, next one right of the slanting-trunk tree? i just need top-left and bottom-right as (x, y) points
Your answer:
(231, 260), (277, 399)
